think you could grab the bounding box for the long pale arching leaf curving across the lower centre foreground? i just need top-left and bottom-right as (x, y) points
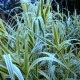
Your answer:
(29, 52), (76, 75)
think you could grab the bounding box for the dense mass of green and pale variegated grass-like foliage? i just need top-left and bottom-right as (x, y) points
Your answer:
(0, 0), (80, 80)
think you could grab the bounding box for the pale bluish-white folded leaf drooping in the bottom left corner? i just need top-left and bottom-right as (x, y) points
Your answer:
(3, 54), (24, 80)
